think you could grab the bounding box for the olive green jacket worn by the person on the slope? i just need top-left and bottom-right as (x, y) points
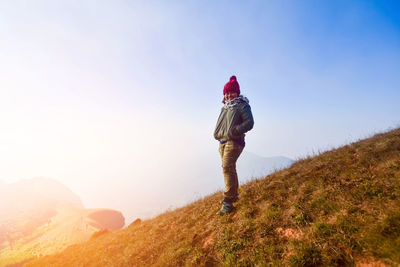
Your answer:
(214, 101), (254, 142)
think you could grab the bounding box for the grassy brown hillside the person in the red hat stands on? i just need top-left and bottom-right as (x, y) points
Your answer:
(27, 129), (400, 266)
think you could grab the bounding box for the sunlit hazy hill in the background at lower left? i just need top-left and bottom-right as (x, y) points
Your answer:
(0, 178), (124, 266)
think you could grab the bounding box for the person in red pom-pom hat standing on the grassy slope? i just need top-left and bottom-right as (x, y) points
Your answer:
(214, 76), (254, 215)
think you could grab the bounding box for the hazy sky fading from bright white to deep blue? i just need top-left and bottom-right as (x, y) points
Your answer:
(0, 0), (400, 222)
